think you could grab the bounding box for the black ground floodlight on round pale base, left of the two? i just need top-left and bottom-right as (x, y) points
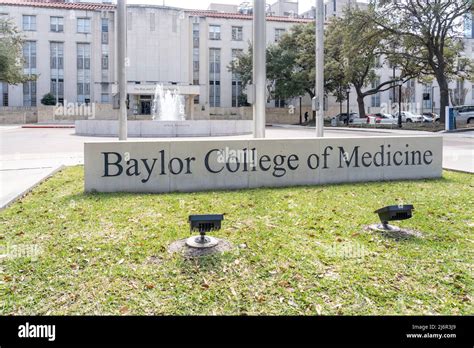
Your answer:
(186, 214), (224, 249)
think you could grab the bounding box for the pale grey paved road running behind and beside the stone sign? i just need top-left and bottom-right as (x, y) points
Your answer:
(0, 126), (474, 209)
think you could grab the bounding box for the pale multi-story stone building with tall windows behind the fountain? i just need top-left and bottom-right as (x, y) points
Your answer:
(0, 0), (474, 118)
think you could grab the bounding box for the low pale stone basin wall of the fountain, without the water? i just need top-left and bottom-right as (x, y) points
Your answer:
(75, 120), (253, 138)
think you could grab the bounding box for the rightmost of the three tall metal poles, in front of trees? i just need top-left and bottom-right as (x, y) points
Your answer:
(314, 0), (324, 137)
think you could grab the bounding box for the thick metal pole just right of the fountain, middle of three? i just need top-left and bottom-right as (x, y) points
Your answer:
(253, 0), (267, 138)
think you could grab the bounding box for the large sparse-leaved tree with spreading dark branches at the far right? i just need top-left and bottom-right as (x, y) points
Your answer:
(369, 0), (472, 122)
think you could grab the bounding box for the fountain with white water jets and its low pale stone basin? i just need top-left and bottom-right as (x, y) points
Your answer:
(75, 84), (252, 138)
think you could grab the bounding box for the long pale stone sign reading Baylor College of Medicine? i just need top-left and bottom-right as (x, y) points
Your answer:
(84, 136), (443, 192)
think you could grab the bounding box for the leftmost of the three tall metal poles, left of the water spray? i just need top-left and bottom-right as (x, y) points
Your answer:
(117, 0), (127, 140)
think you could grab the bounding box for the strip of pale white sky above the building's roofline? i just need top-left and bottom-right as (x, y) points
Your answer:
(127, 0), (332, 13)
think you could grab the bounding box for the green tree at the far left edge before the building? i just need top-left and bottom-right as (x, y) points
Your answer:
(0, 19), (36, 84)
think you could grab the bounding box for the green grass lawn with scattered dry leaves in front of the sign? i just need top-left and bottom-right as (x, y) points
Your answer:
(0, 166), (474, 315)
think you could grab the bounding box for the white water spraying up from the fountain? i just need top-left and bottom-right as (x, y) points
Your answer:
(152, 84), (185, 121)
